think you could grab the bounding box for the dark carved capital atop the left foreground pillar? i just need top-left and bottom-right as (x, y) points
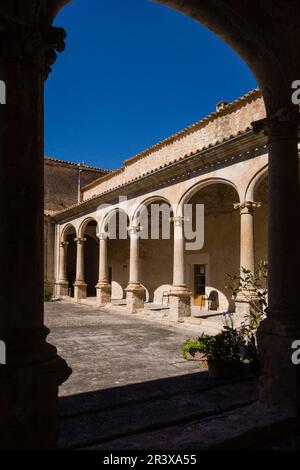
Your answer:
(0, 17), (66, 80)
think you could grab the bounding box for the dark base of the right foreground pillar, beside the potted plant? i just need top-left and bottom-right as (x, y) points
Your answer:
(257, 311), (300, 419)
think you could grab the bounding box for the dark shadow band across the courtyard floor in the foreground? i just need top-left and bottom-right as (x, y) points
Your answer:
(59, 367), (258, 449)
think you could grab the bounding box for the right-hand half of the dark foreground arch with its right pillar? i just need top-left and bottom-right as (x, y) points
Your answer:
(51, 0), (300, 413)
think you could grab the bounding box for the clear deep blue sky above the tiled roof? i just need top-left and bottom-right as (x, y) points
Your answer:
(45, 0), (256, 169)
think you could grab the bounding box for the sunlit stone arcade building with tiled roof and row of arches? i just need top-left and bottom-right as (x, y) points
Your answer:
(46, 90), (276, 321)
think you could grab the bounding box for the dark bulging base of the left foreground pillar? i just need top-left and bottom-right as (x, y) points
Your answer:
(0, 328), (72, 449)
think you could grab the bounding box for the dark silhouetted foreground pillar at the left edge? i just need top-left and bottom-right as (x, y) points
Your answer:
(0, 22), (71, 449)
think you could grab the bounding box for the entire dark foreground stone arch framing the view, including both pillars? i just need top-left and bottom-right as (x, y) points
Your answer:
(0, 0), (300, 448)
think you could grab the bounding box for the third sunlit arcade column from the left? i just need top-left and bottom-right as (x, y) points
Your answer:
(96, 233), (111, 307)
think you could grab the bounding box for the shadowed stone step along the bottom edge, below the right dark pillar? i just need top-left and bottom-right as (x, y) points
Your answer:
(85, 401), (292, 451)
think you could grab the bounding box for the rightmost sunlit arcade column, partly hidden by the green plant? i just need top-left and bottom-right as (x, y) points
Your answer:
(234, 201), (261, 319)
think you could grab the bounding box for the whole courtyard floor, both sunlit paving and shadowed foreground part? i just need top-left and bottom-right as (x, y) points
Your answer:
(45, 301), (258, 450)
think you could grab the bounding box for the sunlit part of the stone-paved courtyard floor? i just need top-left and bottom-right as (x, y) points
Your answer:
(45, 301), (207, 396)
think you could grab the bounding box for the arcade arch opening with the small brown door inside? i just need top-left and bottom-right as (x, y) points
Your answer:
(186, 182), (240, 311)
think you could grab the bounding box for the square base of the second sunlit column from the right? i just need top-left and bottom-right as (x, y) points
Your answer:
(169, 286), (192, 322)
